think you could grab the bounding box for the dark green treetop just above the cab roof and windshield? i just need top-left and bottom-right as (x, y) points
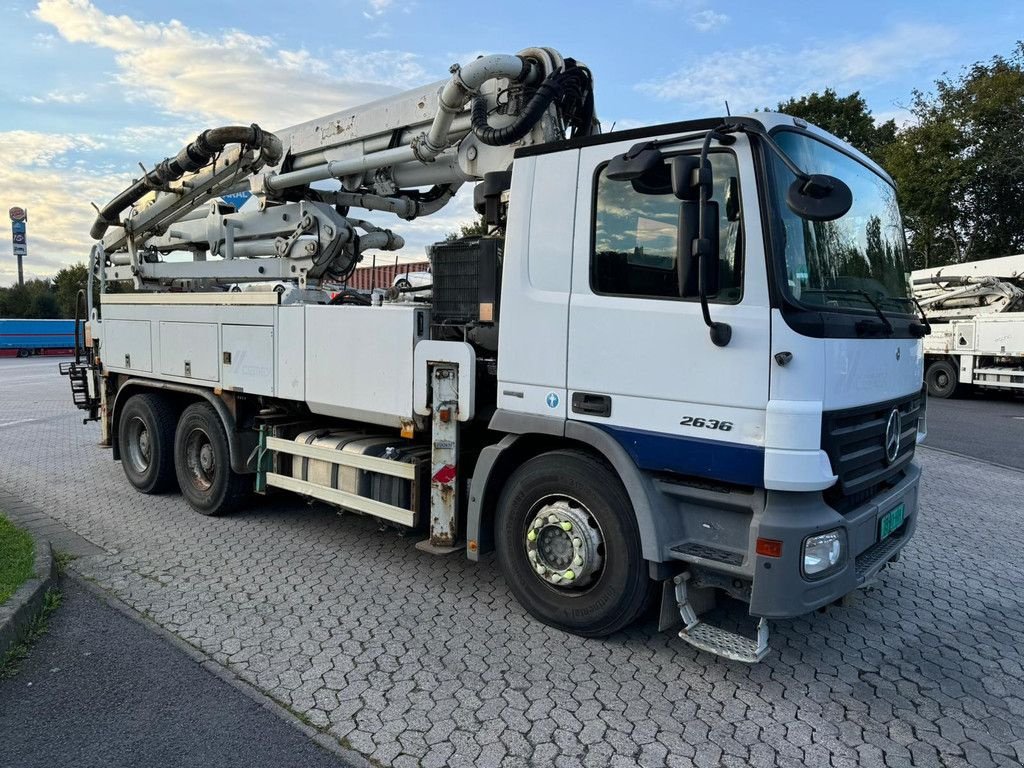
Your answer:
(778, 88), (896, 158)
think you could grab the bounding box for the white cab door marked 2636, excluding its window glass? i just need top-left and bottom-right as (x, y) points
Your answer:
(568, 137), (769, 430)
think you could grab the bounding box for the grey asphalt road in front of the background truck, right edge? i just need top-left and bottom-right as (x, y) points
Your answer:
(925, 392), (1024, 469)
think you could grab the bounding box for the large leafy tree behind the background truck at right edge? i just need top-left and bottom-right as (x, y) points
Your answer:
(883, 42), (1024, 266)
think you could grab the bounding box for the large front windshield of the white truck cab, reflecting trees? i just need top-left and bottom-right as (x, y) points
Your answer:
(769, 131), (913, 313)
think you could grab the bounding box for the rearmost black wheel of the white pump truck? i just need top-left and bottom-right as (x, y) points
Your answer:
(118, 394), (175, 494)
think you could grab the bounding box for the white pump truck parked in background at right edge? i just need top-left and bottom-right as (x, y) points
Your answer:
(911, 254), (1024, 397)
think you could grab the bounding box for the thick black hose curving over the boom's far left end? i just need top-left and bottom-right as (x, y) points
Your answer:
(89, 123), (284, 240)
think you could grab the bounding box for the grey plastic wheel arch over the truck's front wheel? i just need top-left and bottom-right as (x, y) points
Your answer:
(466, 411), (666, 563)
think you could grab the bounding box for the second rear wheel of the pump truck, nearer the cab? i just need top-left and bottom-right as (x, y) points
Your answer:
(174, 402), (250, 515)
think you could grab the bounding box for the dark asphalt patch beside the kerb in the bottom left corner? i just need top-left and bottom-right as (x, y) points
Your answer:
(0, 579), (345, 768)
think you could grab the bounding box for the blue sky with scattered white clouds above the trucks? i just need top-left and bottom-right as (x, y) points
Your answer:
(0, 0), (1024, 286)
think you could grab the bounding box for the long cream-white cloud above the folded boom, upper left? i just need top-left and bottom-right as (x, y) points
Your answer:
(35, 0), (424, 129)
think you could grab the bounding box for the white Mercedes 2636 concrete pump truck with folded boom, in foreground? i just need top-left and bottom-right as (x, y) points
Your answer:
(65, 48), (926, 662)
